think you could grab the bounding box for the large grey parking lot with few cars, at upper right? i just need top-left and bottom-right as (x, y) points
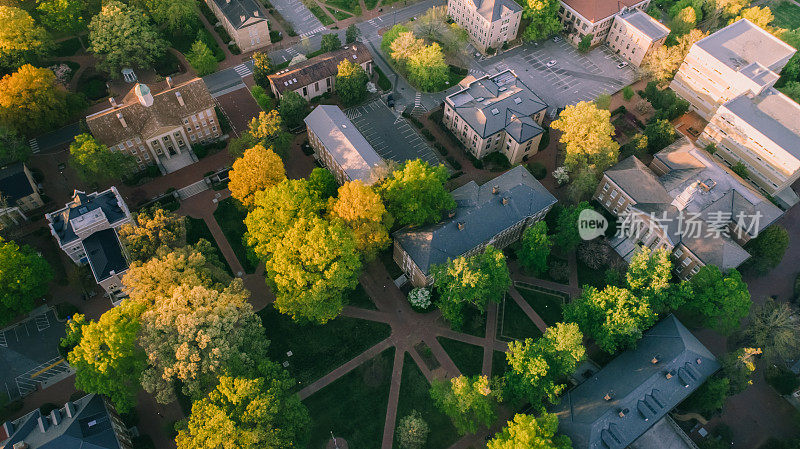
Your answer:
(485, 39), (636, 108)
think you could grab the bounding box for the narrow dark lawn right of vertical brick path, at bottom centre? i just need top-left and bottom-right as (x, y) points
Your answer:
(396, 354), (458, 449)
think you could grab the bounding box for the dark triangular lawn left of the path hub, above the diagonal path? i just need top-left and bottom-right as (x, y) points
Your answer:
(258, 306), (391, 388)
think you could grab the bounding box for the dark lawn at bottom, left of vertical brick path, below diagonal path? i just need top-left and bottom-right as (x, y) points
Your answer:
(303, 348), (395, 449)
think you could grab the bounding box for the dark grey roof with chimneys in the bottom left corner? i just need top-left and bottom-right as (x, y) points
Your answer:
(0, 394), (121, 449)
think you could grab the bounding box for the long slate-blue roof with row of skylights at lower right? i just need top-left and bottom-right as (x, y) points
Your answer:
(553, 315), (719, 449)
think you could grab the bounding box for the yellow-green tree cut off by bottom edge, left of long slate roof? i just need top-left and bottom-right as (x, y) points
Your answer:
(486, 413), (572, 449)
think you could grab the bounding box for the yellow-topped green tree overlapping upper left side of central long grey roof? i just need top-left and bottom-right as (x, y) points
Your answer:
(378, 159), (456, 226)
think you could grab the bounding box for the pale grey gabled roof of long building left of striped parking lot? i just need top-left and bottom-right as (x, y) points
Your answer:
(304, 105), (386, 185)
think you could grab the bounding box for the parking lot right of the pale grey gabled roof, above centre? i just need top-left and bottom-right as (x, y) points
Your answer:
(345, 99), (442, 165)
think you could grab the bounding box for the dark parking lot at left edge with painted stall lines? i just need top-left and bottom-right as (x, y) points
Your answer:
(0, 309), (72, 400)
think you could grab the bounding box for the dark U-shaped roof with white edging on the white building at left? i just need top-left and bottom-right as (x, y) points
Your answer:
(46, 189), (127, 245)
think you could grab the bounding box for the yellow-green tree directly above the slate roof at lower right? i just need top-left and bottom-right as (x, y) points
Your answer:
(564, 286), (656, 354)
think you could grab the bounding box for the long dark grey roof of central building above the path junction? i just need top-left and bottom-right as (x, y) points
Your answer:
(395, 166), (556, 275)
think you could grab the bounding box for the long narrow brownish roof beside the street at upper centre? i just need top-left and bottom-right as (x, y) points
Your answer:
(269, 43), (372, 95)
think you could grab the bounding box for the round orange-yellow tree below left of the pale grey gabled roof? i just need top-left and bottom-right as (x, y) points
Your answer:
(228, 145), (286, 208)
